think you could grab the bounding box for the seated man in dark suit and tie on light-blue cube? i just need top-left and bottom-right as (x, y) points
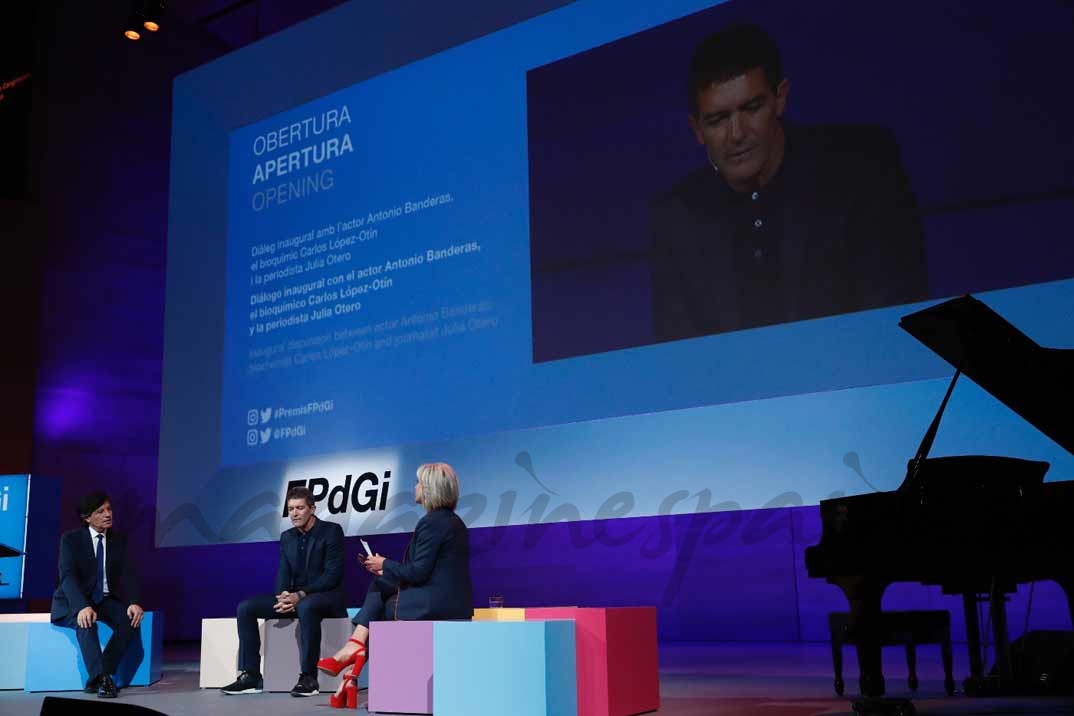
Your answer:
(52, 492), (143, 699)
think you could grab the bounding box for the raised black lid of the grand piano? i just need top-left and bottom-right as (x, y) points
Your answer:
(899, 295), (1074, 454)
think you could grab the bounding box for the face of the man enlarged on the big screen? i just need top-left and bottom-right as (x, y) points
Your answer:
(690, 68), (789, 191)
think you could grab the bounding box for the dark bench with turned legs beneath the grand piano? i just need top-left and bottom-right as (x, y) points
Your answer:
(828, 610), (955, 696)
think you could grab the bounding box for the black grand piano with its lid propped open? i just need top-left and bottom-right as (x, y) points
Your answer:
(806, 296), (1074, 698)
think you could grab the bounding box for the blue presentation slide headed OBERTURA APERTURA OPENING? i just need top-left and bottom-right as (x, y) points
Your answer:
(221, 64), (529, 464)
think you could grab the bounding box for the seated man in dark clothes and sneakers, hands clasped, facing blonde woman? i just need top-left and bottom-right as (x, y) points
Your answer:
(222, 487), (347, 697)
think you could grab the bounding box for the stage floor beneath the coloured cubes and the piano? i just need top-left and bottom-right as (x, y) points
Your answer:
(0, 642), (1074, 716)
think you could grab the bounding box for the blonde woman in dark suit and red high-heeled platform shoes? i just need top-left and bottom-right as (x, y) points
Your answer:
(317, 463), (474, 708)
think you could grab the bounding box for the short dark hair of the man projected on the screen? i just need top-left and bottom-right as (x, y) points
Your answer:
(687, 23), (783, 115)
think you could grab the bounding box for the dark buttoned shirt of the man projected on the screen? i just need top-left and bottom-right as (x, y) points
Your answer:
(651, 125), (928, 340)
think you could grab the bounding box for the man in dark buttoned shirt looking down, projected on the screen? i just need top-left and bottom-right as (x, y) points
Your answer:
(651, 25), (928, 340)
